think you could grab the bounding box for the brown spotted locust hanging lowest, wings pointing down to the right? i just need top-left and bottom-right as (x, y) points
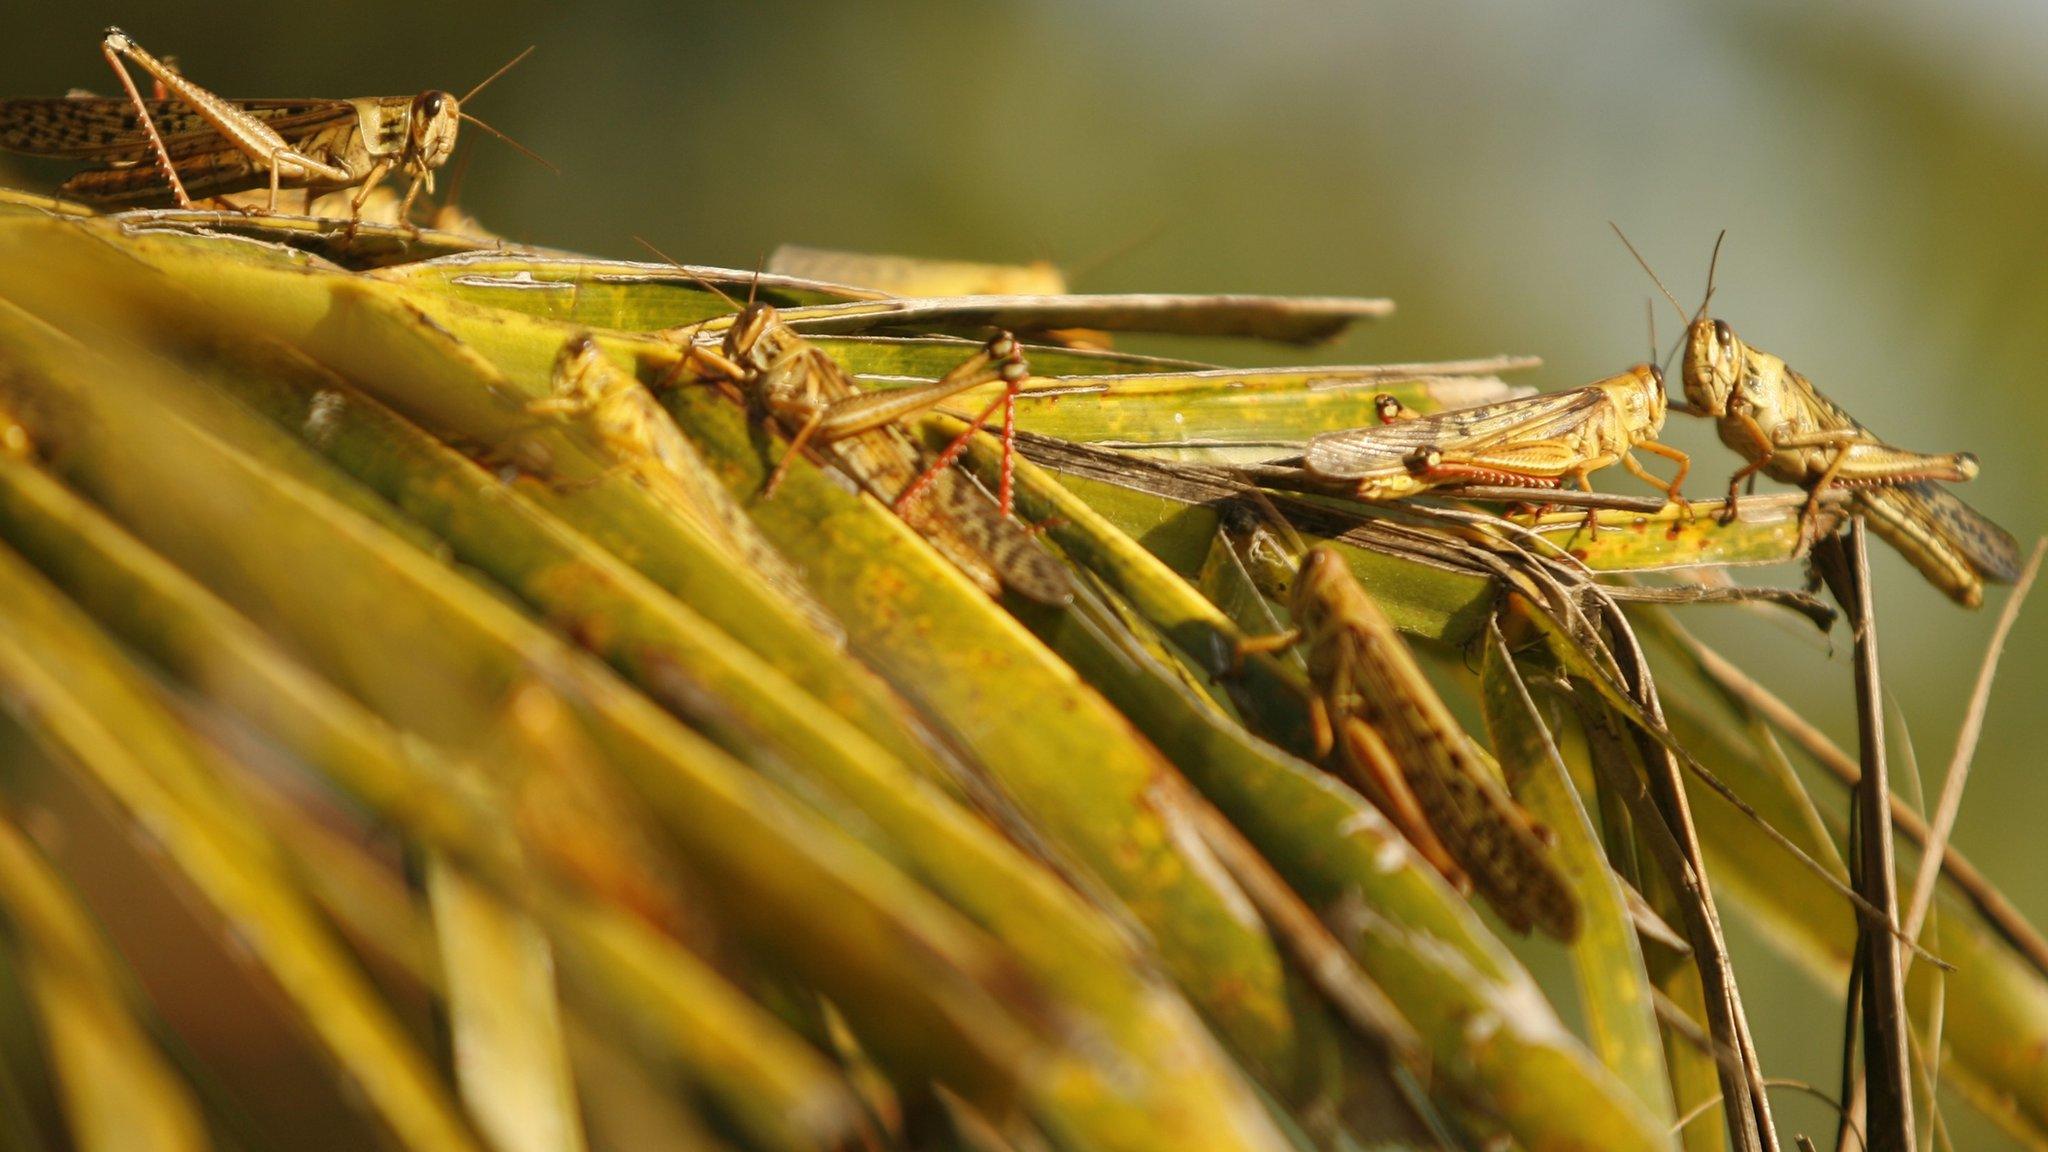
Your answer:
(1239, 529), (1579, 941)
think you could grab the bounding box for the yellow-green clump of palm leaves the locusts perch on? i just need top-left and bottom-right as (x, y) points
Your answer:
(0, 197), (2048, 1152)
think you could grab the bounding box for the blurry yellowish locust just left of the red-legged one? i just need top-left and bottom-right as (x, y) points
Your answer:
(526, 332), (844, 640)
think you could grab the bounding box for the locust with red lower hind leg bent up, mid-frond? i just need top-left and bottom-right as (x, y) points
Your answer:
(664, 272), (1073, 605)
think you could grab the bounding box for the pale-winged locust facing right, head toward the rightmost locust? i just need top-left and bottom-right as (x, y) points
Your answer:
(1303, 365), (1692, 504)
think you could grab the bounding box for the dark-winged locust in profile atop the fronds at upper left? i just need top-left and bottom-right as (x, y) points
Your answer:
(0, 29), (532, 219)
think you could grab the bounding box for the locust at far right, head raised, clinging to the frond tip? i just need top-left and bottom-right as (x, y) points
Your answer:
(1683, 318), (2019, 609)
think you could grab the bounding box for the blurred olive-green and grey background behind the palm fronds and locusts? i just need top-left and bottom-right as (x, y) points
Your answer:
(0, 0), (2048, 1127)
